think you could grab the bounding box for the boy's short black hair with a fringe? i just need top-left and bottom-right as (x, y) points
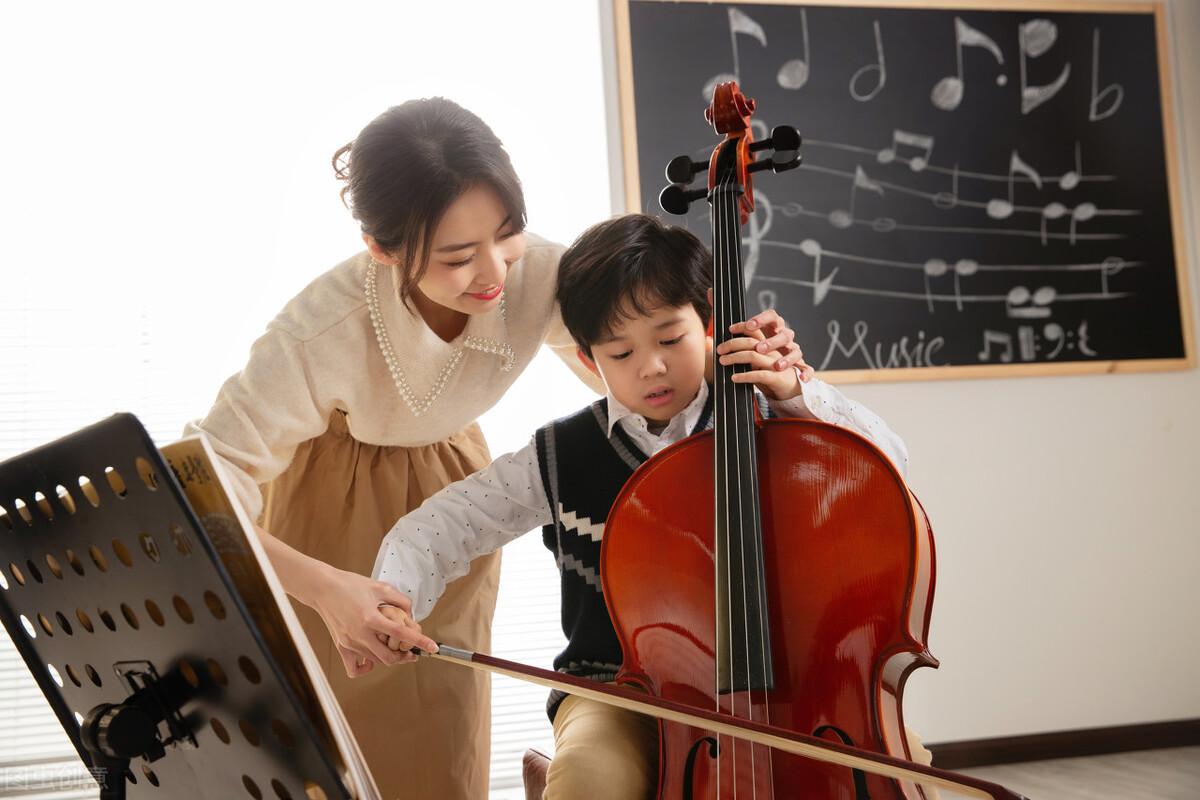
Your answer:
(557, 213), (713, 359)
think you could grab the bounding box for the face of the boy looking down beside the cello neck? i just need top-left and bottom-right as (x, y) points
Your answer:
(581, 305), (710, 425)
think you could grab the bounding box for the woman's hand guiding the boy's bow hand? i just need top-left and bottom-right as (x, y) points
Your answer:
(310, 570), (438, 678)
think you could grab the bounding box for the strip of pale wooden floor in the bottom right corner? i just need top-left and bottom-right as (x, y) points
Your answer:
(942, 747), (1200, 800)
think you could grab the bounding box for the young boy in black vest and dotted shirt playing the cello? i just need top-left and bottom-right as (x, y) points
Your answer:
(373, 215), (907, 800)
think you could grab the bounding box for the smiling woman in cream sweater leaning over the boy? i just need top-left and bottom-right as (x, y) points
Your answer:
(190, 98), (800, 800)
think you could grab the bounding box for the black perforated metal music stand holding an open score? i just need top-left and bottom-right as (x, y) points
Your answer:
(0, 414), (352, 800)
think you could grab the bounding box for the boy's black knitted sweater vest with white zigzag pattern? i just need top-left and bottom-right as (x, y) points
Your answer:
(534, 392), (769, 720)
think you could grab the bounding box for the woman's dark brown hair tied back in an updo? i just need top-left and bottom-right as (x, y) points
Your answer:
(334, 97), (526, 302)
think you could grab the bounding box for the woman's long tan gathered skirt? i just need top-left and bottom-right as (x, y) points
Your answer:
(263, 413), (500, 800)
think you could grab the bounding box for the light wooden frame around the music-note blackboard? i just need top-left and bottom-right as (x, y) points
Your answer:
(601, 0), (1195, 383)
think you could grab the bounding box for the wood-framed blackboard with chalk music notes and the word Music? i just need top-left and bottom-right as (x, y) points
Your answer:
(614, 0), (1194, 380)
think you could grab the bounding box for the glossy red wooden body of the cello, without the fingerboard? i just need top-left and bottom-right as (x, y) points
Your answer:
(601, 420), (937, 800)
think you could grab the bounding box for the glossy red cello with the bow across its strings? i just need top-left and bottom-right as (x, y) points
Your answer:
(414, 82), (1022, 800)
